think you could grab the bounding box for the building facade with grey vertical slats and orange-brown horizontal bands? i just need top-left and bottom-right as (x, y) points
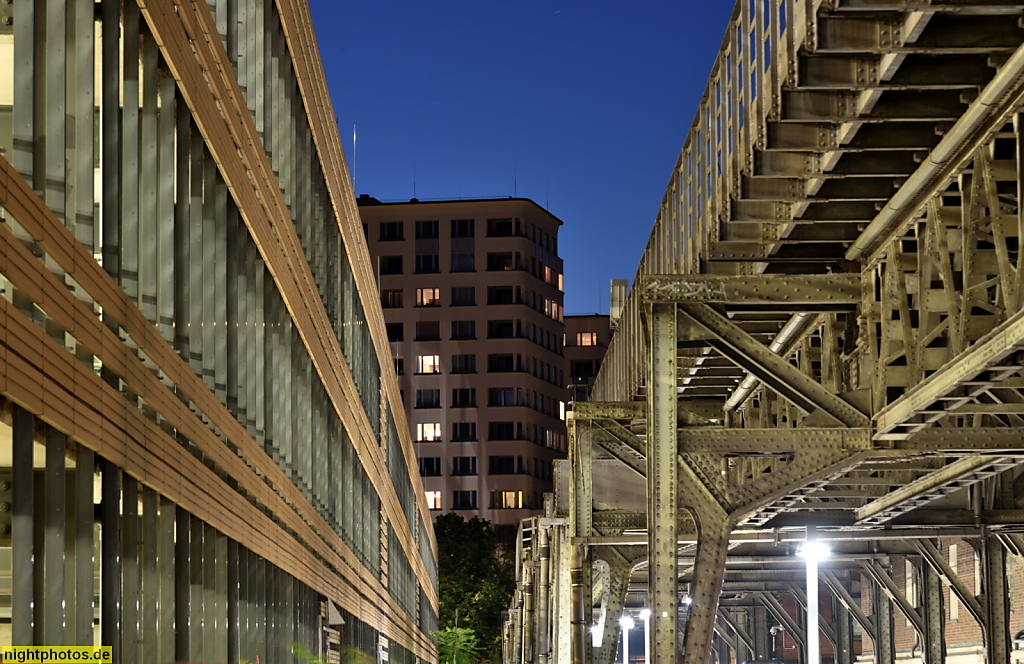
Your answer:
(0, 0), (437, 664)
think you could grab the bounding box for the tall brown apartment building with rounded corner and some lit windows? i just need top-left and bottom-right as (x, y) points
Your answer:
(358, 196), (567, 525)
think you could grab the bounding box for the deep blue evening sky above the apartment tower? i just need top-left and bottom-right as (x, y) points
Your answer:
(310, 0), (733, 314)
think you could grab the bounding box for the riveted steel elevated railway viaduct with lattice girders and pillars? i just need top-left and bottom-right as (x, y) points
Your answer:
(507, 0), (1024, 664)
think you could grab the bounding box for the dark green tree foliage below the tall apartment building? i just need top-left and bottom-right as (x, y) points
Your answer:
(434, 512), (515, 664)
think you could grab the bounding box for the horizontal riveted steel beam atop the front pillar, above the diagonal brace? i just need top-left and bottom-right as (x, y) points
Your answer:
(640, 275), (862, 308)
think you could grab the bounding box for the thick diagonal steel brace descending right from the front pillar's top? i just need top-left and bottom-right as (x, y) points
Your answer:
(679, 303), (870, 427)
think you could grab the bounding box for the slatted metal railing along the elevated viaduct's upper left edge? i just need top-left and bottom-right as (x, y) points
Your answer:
(592, 0), (824, 401)
